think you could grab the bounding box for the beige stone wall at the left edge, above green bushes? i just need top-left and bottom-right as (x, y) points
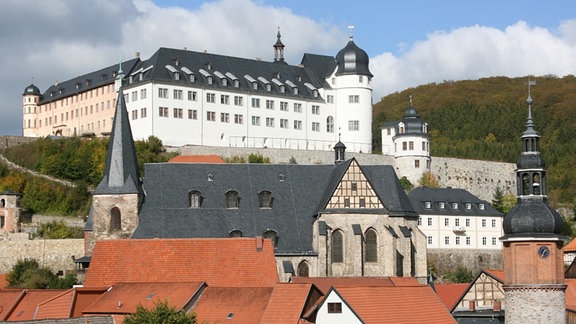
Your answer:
(0, 233), (84, 273)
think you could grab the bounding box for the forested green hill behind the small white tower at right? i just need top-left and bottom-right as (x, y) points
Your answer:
(373, 75), (576, 205)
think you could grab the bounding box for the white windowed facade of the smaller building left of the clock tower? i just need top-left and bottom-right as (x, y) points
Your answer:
(418, 211), (504, 250)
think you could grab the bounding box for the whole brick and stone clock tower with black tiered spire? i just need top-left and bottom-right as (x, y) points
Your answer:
(500, 81), (566, 324)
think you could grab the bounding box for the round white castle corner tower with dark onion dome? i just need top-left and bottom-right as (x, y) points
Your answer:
(326, 30), (372, 153)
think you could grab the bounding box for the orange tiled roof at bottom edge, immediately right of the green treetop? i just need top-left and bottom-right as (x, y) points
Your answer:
(193, 286), (273, 323)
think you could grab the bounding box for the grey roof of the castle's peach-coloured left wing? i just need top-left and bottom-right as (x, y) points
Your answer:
(39, 58), (140, 105)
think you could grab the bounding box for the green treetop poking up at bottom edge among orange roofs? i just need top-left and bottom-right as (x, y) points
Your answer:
(122, 301), (196, 324)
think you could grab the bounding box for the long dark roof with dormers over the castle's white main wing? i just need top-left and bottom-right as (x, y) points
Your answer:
(128, 47), (336, 100)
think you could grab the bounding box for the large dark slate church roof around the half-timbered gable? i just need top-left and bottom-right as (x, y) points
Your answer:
(132, 160), (417, 254)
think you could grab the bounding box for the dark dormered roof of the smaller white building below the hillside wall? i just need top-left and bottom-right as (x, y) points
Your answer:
(408, 186), (504, 217)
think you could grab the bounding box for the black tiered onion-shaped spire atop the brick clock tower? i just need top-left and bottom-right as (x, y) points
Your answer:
(503, 81), (564, 239)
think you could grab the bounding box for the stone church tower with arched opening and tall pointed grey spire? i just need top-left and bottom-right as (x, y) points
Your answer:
(84, 64), (144, 255)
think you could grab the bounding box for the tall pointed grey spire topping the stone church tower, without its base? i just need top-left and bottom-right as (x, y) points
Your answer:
(94, 65), (143, 194)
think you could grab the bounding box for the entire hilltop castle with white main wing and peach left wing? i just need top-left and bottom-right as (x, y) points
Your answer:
(23, 32), (372, 153)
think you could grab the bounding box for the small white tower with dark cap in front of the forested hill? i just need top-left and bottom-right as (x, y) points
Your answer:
(382, 96), (430, 185)
